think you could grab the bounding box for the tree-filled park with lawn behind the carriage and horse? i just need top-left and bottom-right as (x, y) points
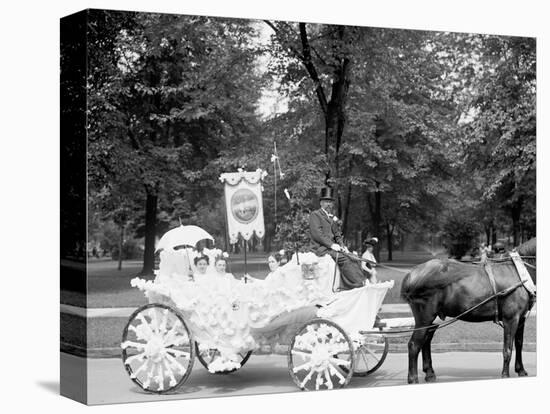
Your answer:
(61, 4), (536, 376)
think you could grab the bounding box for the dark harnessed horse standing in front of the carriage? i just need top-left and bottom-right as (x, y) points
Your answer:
(401, 238), (536, 384)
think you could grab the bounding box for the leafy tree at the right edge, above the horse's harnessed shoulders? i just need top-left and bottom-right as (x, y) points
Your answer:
(464, 36), (536, 245)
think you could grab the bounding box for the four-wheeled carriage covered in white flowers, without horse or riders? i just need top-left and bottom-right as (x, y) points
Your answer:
(121, 226), (393, 394)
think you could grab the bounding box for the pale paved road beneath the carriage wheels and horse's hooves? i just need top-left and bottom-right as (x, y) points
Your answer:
(61, 352), (536, 404)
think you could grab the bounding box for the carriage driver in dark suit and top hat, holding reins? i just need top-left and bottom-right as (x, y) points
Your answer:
(309, 187), (367, 290)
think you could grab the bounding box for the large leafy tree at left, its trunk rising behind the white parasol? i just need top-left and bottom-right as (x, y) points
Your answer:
(89, 11), (266, 274)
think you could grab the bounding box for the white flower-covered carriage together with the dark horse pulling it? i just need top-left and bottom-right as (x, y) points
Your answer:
(121, 225), (536, 394)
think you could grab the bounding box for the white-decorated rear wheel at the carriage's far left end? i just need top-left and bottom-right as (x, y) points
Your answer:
(121, 304), (195, 394)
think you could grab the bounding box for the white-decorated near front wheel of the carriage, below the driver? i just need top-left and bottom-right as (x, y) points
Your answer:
(288, 318), (354, 391)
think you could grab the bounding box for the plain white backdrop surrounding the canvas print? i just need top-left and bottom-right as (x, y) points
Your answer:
(0, 0), (550, 413)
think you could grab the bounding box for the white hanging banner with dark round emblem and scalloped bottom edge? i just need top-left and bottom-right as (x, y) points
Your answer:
(220, 169), (267, 243)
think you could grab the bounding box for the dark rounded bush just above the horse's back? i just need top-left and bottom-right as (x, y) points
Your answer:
(443, 217), (478, 259)
